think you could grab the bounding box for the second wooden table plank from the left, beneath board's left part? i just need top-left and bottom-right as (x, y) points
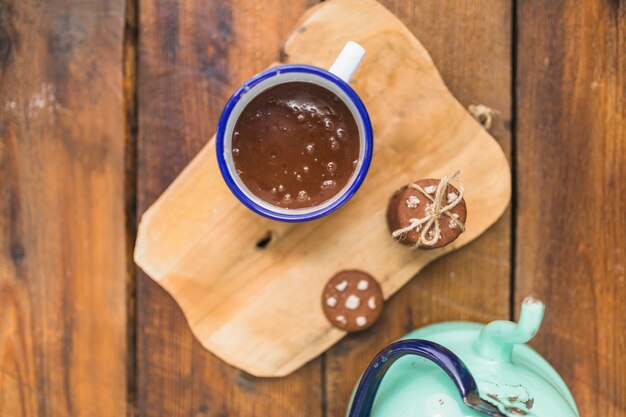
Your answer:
(137, 0), (322, 417)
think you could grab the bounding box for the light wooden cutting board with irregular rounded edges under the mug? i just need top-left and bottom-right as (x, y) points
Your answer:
(135, 0), (511, 376)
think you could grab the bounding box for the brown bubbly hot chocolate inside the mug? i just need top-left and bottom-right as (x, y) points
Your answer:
(232, 82), (360, 209)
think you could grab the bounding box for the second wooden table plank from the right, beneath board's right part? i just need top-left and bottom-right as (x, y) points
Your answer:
(325, 0), (512, 416)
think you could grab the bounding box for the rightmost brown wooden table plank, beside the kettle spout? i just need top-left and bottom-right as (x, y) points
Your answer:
(516, 1), (626, 417)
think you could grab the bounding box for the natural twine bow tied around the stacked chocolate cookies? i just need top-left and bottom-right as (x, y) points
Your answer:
(391, 170), (465, 247)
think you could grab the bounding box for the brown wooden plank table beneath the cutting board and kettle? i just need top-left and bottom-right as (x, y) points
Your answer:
(0, 0), (626, 417)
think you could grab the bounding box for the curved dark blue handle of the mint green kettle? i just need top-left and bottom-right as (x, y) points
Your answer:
(348, 339), (506, 417)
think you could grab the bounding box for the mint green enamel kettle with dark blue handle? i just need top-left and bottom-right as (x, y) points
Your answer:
(348, 297), (578, 417)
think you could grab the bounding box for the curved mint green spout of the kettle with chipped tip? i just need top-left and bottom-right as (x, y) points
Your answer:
(476, 296), (545, 362)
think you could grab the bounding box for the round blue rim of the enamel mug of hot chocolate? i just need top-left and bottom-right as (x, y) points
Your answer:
(215, 64), (374, 222)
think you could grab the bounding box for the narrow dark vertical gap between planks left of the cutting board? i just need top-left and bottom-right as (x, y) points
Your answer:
(122, 0), (139, 417)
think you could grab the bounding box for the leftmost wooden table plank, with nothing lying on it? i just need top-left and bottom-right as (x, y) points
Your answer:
(0, 0), (127, 417)
